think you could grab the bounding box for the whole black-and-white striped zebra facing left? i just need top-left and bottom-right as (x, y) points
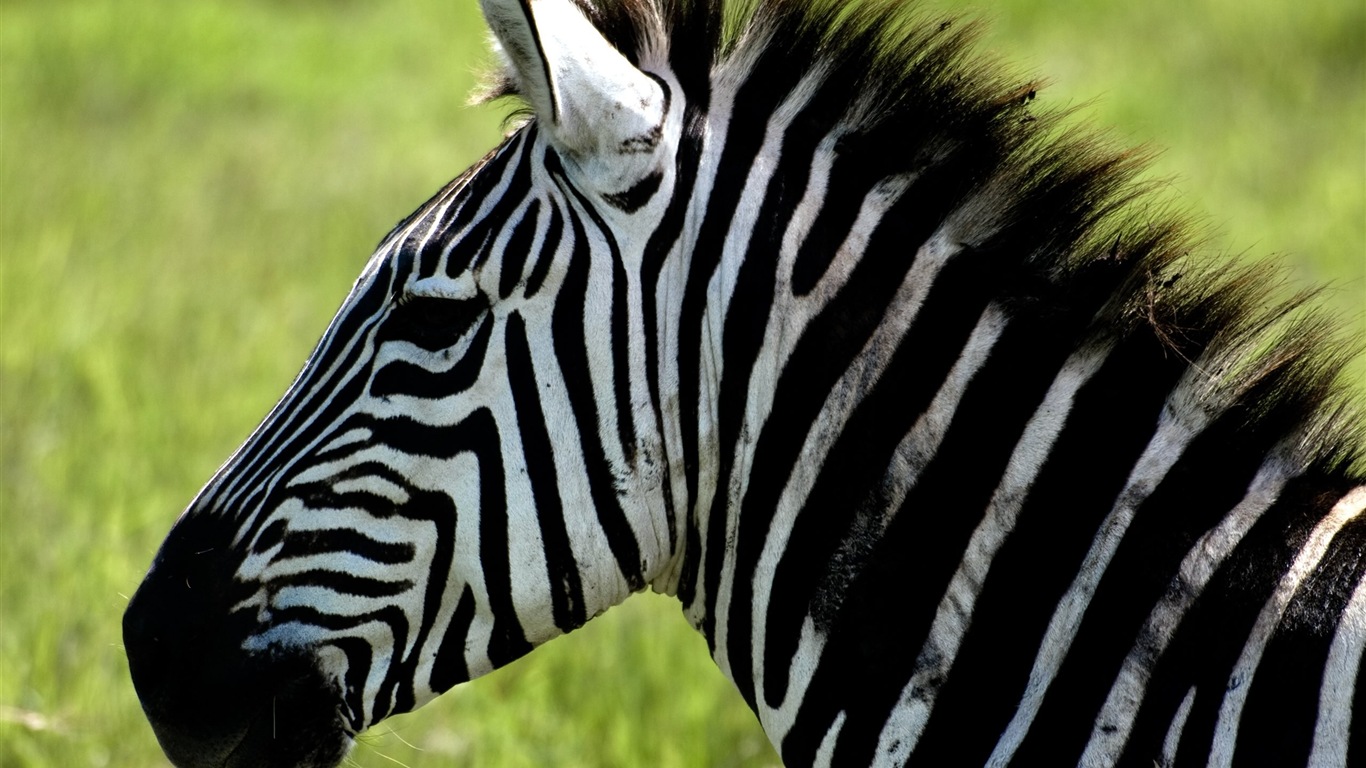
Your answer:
(123, 0), (1366, 767)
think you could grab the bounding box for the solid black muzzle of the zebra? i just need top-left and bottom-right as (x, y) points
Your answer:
(123, 508), (351, 768)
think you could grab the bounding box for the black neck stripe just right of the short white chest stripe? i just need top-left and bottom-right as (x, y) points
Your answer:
(813, 292), (1098, 764)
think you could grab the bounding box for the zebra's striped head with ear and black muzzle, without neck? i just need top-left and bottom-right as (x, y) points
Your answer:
(124, 0), (682, 767)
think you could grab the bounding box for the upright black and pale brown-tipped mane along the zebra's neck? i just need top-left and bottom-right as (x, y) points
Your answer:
(486, 0), (1366, 476)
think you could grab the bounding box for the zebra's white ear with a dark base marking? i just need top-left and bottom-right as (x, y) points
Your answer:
(479, 0), (668, 193)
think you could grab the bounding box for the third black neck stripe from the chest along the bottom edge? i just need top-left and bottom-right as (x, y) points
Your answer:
(904, 327), (1186, 765)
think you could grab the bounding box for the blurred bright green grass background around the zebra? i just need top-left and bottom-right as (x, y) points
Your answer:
(0, 0), (1366, 768)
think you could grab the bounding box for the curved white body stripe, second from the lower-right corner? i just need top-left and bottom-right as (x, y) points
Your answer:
(1209, 486), (1366, 768)
